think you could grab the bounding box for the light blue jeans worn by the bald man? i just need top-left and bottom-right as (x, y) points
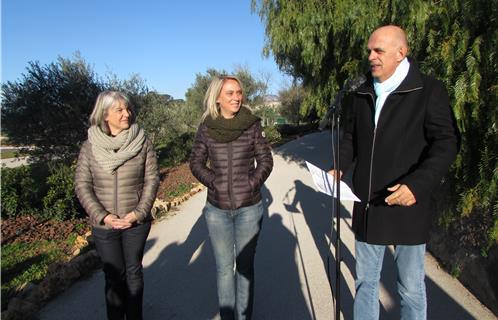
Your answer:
(354, 241), (427, 320)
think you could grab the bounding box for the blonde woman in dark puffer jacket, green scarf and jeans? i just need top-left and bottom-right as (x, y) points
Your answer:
(190, 76), (273, 320)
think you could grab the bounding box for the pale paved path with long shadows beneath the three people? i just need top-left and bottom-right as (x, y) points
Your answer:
(39, 132), (496, 320)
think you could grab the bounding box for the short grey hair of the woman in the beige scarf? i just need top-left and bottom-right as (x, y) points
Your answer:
(90, 91), (135, 134)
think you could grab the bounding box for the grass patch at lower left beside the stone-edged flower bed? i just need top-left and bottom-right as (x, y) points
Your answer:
(1, 232), (77, 308)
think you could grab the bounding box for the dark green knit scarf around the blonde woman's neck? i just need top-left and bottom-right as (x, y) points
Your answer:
(204, 106), (260, 143)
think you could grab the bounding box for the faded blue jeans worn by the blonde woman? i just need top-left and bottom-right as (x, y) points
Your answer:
(203, 201), (263, 320)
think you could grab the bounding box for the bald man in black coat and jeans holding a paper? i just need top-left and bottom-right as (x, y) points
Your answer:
(330, 26), (458, 319)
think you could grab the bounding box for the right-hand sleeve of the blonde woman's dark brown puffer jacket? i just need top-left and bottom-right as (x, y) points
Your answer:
(252, 121), (273, 189)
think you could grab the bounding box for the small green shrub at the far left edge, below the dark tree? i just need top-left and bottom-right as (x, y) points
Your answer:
(1, 166), (40, 218)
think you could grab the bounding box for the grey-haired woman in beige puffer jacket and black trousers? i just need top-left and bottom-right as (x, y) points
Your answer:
(75, 91), (159, 320)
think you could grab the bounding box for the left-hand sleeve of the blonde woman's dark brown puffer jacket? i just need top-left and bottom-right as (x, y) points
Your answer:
(189, 124), (215, 188)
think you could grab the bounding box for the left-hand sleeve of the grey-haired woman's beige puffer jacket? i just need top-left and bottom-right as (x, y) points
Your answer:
(74, 142), (109, 225)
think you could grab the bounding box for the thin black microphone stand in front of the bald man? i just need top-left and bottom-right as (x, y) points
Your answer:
(327, 89), (347, 320)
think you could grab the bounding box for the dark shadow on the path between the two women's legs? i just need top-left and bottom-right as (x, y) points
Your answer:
(140, 211), (218, 319)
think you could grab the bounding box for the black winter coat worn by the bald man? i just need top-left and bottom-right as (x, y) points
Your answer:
(340, 61), (458, 245)
